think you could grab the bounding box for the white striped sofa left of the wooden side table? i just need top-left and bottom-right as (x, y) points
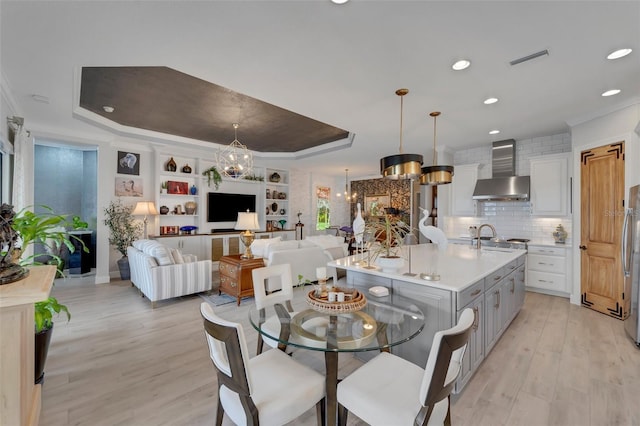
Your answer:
(127, 240), (212, 308)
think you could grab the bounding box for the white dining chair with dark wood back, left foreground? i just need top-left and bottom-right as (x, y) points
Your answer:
(200, 302), (325, 426)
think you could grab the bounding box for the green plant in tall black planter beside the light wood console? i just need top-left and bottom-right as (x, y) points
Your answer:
(34, 297), (71, 384)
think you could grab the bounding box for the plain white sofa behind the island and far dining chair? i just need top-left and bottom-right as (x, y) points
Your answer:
(251, 235), (348, 291)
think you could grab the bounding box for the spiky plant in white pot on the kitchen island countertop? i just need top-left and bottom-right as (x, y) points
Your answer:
(364, 213), (411, 272)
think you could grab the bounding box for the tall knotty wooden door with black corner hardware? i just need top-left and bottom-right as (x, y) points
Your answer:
(580, 142), (629, 319)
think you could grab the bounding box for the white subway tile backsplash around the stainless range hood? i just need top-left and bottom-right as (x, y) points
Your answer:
(441, 133), (572, 243)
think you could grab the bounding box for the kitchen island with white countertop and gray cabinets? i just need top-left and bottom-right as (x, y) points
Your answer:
(329, 244), (527, 393)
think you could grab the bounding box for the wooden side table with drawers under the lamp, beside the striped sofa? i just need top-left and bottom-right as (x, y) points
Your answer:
(218, 254), (264, 306)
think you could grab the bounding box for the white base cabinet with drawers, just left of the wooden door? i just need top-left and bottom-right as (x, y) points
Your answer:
(527, 244), (571, 297)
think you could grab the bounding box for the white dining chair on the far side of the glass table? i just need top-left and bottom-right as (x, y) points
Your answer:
(251, 263), (296, 354)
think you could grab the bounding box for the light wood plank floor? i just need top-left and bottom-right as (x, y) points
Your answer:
(40, 278), (640, 426)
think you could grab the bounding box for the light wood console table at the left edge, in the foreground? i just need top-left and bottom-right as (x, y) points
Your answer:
(0, 266), (56, 426)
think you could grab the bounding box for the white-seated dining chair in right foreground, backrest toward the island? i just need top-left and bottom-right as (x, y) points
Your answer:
(338, 309), (475, 426)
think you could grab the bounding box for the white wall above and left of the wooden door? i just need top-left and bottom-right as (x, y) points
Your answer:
(571, 103), (640, 305)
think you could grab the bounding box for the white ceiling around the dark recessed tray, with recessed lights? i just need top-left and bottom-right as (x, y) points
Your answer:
(0, 0), (640, 176)
